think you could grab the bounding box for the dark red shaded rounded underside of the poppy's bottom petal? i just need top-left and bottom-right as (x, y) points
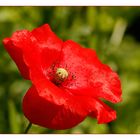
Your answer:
(23, 87), (85, 130)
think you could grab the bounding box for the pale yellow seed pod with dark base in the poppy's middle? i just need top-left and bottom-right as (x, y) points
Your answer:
(55, 68), (69, 84)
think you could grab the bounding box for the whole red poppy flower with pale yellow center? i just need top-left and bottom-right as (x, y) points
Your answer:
(3, 24), (121, 129)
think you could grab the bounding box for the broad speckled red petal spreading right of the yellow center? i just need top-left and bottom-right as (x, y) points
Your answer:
(60, 40), (121, 103)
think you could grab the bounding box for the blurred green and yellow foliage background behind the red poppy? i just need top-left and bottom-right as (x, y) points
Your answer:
(0, 7), (140, 134)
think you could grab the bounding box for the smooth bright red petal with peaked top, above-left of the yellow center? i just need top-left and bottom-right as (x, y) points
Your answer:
(31, 24), (63, 70)
